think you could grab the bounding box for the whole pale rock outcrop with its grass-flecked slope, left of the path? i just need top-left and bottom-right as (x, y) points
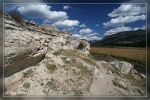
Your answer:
(4, 15), (92, 95)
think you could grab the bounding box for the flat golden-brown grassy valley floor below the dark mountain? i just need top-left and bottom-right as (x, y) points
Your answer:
(90, 47), (146, 73)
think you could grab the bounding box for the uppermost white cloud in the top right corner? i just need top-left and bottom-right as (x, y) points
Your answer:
(108, 4), (146, 17)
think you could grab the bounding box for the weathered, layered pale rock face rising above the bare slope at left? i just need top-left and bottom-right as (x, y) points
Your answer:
(4, 15), (88, 76)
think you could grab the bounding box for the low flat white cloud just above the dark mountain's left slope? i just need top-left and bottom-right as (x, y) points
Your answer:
(105, 26), (132, 35)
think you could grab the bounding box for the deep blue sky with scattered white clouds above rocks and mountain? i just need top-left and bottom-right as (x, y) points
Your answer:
(4, 3), (146, 40)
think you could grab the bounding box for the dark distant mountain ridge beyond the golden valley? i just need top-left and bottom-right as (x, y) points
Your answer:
(91, 29), (146, 47)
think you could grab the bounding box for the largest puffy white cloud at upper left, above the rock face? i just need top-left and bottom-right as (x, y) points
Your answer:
(17, 4), (68, 22)
